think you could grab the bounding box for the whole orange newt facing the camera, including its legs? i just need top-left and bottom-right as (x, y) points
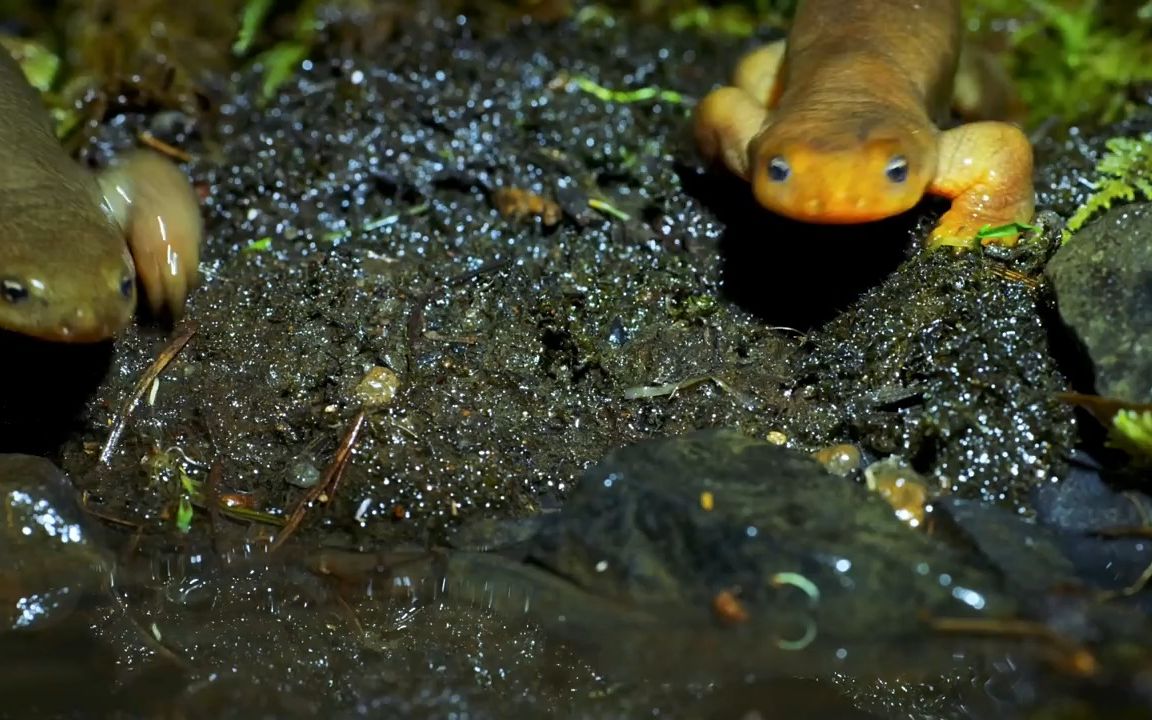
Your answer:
(695, 0), (1036, 247)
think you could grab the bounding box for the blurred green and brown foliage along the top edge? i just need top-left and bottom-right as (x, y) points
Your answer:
(0, 0), (1152, 135)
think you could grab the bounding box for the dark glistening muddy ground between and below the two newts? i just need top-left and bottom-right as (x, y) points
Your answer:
(3, 1), (1142, 718)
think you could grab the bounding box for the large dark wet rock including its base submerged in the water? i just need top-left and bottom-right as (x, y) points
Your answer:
(437, 430), (1016, 677)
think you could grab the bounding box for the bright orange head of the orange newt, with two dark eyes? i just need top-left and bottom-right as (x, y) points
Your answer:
(749, 124), (937, 225)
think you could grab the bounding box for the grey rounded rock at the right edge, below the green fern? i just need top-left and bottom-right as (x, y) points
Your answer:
(1046, 203), (1152, 402)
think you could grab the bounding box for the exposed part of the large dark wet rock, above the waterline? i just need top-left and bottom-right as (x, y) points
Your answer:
(530, 430), (1010, 626)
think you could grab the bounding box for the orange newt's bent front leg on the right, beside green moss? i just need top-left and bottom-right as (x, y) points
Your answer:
(927, 122), (1036, 248)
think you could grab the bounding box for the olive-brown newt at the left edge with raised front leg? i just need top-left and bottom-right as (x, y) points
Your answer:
(0, 51), (203, 342)
